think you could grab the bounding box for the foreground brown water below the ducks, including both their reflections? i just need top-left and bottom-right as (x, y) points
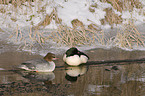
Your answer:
(0, 63), (145, 96)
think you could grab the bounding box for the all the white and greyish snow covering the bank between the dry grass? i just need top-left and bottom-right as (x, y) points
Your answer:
(0, 0), (145, 54)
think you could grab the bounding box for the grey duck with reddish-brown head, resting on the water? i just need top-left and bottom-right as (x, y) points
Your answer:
(18, 53), (58, 72)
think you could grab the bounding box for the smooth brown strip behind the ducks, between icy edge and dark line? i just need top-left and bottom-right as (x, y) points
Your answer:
(0, 48), (145, 70)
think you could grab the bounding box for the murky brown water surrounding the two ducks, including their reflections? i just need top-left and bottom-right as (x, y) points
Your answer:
(0, 49), (145, 96)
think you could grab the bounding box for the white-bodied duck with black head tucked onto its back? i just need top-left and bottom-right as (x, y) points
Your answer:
(63, 47), (89, 66)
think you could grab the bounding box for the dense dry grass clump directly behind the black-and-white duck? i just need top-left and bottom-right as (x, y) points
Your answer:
(50, 25), (104, 47)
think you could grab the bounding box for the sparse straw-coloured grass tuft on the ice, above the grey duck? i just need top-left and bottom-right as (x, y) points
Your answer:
(9, 26), (46, 50)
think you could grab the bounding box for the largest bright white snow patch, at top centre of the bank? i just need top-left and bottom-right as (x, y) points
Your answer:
(58, 0), (110, 27)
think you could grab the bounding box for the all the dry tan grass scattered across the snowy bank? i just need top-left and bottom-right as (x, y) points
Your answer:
(0, 0), (144, 48)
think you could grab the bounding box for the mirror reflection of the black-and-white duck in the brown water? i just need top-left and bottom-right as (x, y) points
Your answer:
(65, 65), (88, 82)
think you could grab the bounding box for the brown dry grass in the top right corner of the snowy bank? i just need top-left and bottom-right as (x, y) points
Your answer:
(100, 0), (144, 28)
